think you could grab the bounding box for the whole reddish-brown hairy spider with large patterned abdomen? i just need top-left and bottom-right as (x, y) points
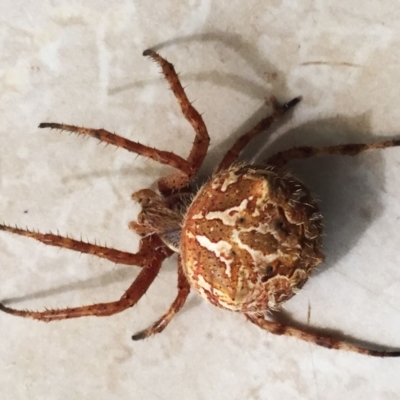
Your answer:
(0, 50), (400, 357)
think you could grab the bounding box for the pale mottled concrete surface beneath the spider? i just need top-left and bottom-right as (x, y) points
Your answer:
(0, 0), (400, 400)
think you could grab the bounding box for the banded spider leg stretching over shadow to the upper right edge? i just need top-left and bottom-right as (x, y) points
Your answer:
(265, 139), (400, 168)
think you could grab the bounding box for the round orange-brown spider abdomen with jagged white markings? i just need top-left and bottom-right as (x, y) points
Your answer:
(180, 165), (323, 312)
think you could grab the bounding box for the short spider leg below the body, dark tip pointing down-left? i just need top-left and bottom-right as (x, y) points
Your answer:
(132, 260), (190, 340)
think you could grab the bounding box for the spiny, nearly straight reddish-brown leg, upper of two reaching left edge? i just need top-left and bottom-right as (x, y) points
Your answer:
(0, 224), (163, 266)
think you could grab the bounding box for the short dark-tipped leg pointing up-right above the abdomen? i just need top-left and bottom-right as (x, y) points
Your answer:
(215, 97), (301, 172)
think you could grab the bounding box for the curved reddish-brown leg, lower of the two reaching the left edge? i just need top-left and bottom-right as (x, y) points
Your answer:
(0, 249), (165, 322)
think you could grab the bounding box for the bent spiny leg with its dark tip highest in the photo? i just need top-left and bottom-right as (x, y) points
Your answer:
(143, 49), (210, 193)
